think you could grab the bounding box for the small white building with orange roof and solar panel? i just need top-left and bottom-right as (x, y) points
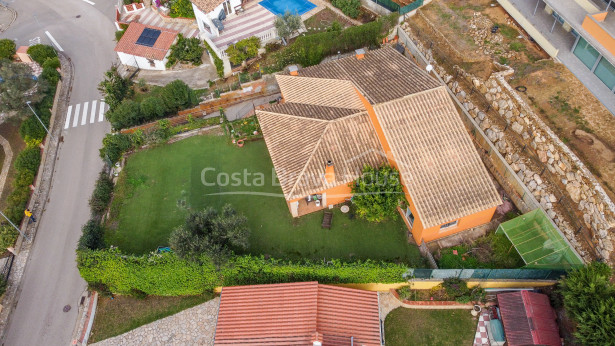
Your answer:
(115, 22), (178, 70)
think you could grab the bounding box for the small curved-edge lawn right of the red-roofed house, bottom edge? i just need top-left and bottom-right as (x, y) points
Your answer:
(384, 307), (478, 346)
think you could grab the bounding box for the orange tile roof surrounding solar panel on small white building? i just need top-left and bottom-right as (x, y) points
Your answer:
(115, 22), (178, 60)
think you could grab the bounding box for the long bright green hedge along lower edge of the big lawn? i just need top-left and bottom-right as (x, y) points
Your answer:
(77, 248), (407, 296)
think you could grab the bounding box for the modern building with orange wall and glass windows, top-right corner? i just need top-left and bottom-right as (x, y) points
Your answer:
(498, 0), (615, 114)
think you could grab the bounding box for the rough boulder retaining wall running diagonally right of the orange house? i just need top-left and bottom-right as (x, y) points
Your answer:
(402, 25), (615, 263)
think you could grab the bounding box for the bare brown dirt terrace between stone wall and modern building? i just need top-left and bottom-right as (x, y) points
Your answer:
(408, 0), (615, 198)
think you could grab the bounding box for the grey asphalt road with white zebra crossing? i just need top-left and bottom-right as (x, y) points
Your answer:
(1, 0), (116, 346)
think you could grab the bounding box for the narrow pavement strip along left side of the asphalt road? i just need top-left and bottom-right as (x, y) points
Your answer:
(0, 52), (74, 343)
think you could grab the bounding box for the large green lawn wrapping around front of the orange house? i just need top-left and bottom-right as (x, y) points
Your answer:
(107, 135), (422, 266)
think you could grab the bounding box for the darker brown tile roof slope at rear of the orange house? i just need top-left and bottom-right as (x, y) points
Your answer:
(292, 47), (439, 104)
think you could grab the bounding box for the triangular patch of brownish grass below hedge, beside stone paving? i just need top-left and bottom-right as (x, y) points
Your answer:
(89, 293), (214, 343)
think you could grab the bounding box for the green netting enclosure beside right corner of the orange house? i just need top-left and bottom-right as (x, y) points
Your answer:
(496, 208), (583, 269)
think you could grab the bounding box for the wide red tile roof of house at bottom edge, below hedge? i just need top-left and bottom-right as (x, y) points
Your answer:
(214, 282), (383, 346)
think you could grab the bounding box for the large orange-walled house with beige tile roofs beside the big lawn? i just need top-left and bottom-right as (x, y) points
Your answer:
(257, 47), (502, 244)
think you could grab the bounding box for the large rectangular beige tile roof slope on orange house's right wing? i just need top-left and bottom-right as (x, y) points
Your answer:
(374, 86), (502, 228)
